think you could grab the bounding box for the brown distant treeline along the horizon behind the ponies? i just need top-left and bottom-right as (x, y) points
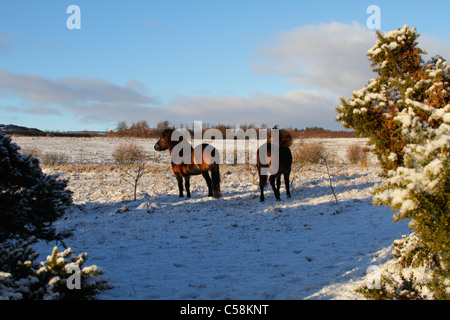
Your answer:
(0, 120), (356, 138)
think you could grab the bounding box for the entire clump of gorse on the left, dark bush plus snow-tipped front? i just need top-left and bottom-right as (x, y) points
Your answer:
(0, 133), (109, 299)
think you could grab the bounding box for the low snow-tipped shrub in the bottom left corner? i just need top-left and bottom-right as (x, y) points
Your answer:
(0, 238), (111, 300)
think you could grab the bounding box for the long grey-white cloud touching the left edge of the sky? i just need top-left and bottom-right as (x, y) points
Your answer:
(0, 70), (160, 123)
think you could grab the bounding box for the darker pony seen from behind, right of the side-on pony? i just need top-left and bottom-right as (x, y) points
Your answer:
(257, 127), (292, 201)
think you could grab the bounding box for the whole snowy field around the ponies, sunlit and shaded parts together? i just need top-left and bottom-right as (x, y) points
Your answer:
(13, 137), (409, 300)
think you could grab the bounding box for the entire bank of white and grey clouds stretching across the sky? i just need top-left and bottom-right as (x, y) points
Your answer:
(0, 23), (386, 129)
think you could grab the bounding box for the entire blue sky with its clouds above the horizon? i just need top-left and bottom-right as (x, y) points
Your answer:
(0, 0), (450, 131)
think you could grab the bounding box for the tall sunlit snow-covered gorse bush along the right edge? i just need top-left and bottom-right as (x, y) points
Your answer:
(336, 25), (450, 298)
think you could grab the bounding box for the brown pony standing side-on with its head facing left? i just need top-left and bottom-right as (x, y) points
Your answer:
(155, 129), (221, 198)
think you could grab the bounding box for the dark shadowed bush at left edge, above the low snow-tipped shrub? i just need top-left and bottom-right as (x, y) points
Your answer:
(0, 132), (72, 242)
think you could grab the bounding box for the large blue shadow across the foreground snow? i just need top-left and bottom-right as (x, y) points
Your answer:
(39, 172), (407, 299)
